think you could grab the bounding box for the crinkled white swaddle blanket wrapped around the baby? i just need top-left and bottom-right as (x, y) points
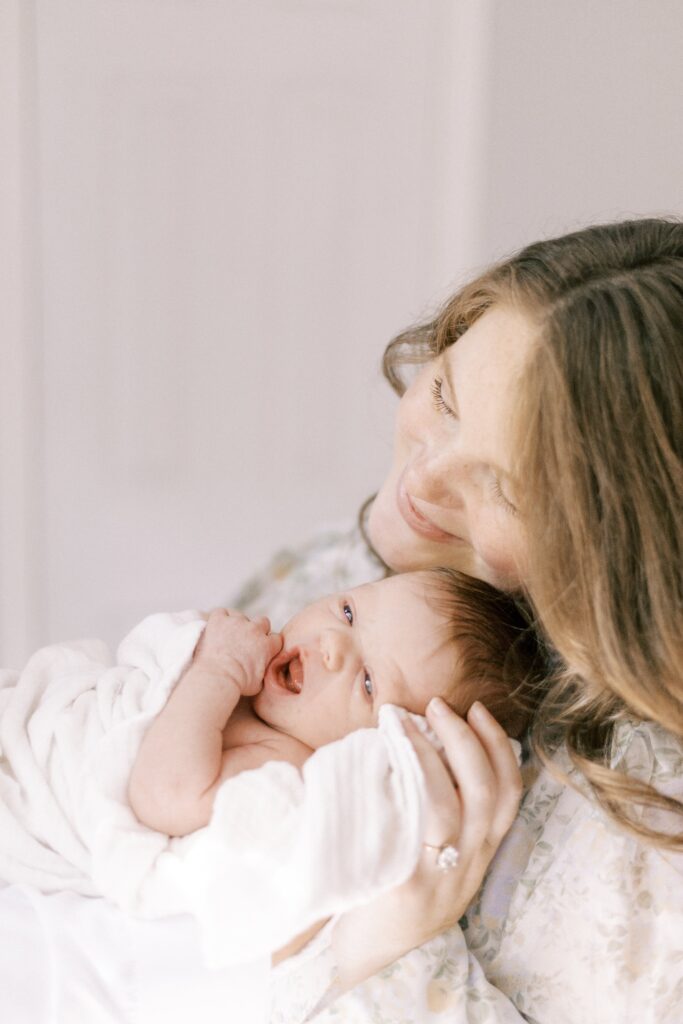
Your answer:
(0, 612), (424, 967)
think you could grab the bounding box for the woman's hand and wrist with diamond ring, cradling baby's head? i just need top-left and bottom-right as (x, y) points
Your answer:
(333, 699), (522, 991)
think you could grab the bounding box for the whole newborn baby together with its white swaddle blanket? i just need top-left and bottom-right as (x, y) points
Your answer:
(0, 569), (537, 970)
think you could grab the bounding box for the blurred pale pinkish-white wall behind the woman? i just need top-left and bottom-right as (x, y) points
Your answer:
(0, 0), (683, 665)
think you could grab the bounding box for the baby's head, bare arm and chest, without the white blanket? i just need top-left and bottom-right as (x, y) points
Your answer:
(128, 569), (536, 836)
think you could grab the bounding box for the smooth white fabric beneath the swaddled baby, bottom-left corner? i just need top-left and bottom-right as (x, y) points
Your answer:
(0, 886), (268, 1024)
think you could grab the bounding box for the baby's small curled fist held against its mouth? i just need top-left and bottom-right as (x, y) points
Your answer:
(195, 608), (283, 697)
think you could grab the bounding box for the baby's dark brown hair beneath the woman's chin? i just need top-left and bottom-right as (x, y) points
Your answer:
(425, 568), (548, 737)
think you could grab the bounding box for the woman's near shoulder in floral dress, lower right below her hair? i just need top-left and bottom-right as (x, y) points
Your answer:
(466, 721), (683, 1022)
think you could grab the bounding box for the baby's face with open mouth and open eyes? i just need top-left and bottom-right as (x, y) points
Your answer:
(253, 572), (458, 750)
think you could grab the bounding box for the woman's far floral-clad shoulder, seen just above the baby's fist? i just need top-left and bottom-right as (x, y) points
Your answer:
(229, 523), (384, 629)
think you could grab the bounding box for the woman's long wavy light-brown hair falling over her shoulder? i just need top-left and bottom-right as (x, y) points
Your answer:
(384, 219), (683, 849)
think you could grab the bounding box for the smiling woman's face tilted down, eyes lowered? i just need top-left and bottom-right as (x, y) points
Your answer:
(369, 306), (533, 590)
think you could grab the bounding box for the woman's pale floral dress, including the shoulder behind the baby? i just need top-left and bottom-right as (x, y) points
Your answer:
(239, 530), (683, 1024)
